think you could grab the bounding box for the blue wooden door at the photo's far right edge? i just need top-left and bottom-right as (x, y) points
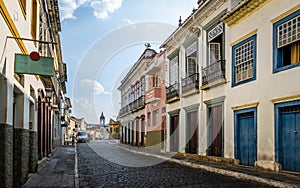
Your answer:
(279, 106), (300, 172)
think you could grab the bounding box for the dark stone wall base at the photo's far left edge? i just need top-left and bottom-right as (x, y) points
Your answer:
(0, 123), (13, 187)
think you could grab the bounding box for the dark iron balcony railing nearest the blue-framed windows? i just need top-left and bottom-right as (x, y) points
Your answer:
(202, 60), (225, 86)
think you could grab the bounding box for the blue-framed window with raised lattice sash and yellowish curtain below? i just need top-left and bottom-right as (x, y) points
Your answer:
(273, 10), (300, 73)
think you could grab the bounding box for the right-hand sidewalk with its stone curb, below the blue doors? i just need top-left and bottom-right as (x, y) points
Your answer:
(120, 144), (300, 187)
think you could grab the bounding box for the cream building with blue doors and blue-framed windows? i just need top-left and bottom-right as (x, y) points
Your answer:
(222, 0), (300, 172)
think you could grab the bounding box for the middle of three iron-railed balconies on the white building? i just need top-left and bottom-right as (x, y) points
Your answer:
(181, 73), (199, 97)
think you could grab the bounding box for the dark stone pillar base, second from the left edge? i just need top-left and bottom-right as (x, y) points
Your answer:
(14, 129), (29, 187)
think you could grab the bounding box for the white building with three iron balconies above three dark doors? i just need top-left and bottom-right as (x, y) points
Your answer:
(161, 0), (229, 157)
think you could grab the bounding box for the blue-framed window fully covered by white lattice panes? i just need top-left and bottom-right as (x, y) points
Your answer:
(232, 35), (256, 86)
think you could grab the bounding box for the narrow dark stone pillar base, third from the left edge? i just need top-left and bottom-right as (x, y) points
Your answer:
(28, 131), (38, 173)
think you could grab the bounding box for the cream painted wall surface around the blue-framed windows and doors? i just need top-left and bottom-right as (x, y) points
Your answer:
(225, 0), (300, 166)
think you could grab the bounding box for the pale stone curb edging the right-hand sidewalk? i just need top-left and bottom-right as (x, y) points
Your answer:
(118, 146), (298, 188)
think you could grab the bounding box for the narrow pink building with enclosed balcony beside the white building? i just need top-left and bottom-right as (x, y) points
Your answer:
(145, 51), (167, 150)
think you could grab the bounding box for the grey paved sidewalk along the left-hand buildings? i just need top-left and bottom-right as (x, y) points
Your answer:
(23, 146), (75, 188)
